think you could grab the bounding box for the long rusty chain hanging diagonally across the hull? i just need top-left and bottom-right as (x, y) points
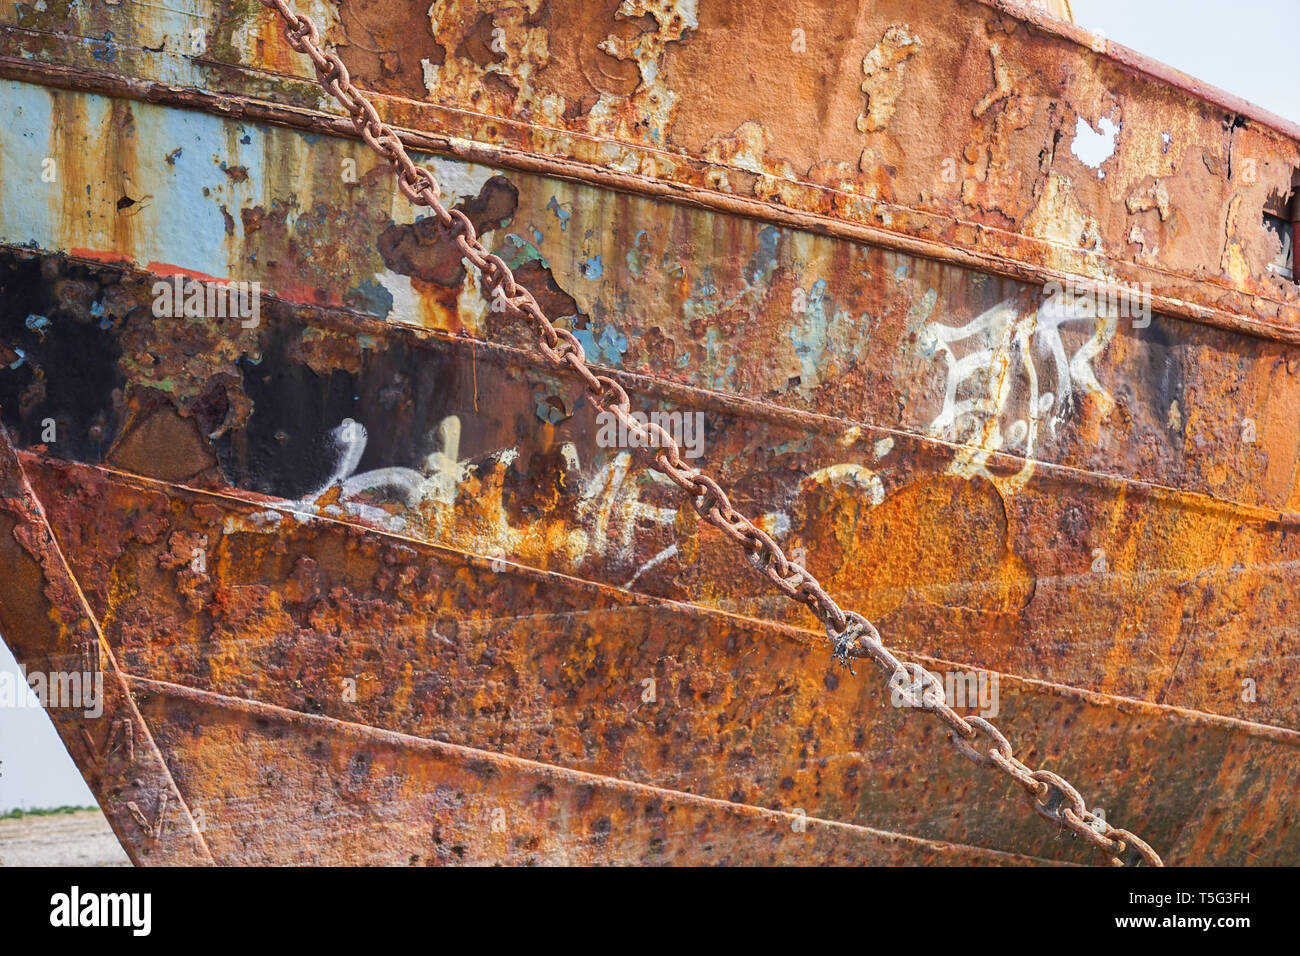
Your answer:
(260, 0), (1164, 866)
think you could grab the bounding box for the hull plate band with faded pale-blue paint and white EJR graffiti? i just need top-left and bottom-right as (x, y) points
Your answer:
(0, 85), (1300, 511)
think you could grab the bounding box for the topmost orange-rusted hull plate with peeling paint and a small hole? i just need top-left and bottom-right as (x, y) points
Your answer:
(0, 0), (1300, 337)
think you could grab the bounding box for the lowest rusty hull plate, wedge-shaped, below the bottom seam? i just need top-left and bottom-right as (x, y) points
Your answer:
(124, 680), (1049, 866)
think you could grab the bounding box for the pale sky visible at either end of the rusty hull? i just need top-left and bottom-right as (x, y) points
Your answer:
(0, 0), (1300, 813)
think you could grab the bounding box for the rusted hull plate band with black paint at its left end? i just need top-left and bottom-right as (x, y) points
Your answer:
(0, 222), (1300, 727)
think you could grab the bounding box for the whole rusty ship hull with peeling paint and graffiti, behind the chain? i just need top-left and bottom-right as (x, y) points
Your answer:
(0, 0), (1300, 865)
